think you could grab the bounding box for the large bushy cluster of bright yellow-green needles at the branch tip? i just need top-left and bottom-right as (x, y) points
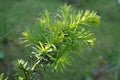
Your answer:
(23, 4), (100, 71)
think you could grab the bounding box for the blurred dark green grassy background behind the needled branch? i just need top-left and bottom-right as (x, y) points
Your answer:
(0, 0), (120, 80)
